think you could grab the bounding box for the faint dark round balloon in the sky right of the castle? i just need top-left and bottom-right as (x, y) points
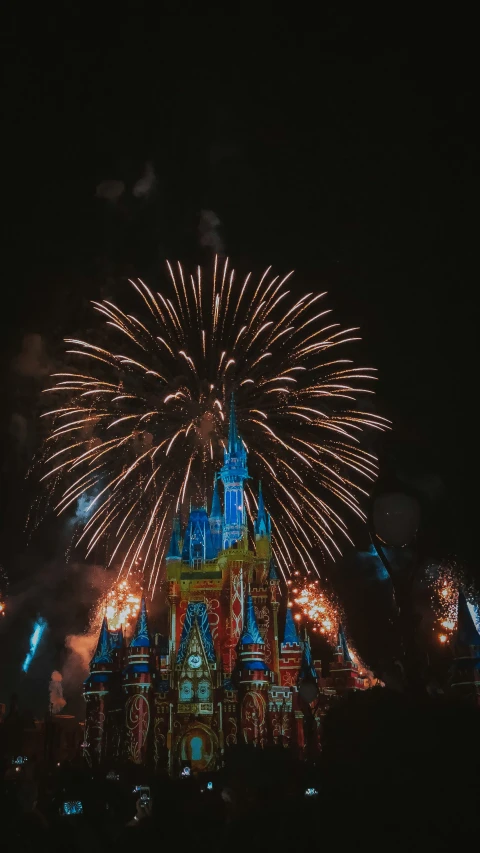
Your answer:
(373, 492), (420, 548)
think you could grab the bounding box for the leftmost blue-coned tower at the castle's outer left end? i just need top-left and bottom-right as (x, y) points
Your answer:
(83, 616), (113, 767)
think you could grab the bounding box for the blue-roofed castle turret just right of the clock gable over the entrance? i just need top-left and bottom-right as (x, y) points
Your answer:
(239, 593), (270, 747)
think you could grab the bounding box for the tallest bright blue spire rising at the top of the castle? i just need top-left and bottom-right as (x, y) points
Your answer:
(220, 394), (248, 548)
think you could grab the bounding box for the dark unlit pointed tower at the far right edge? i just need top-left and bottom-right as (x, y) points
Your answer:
(450, 590), (480, 707)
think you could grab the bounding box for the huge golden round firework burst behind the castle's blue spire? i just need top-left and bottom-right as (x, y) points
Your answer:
(39, 259), (388, 592)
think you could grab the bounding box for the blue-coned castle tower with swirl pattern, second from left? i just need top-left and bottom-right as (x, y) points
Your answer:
(123, 598), (153, 764)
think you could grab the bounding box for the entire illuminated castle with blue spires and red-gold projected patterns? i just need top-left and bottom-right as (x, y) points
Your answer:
(84, 399), (364, 775)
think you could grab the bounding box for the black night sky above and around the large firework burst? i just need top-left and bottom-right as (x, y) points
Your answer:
(0, 13), (478, 712)
